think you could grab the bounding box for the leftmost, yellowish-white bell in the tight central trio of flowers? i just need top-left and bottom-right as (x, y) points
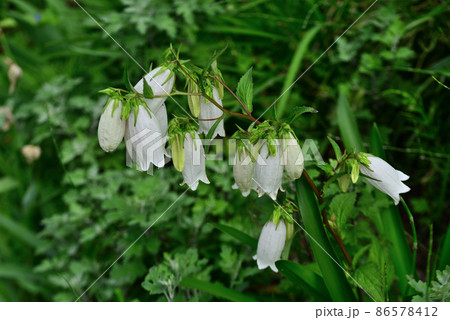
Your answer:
(233, 148), (255, 197)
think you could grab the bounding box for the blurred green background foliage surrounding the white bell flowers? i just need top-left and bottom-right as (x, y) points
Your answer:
(0, 0), (450, 301)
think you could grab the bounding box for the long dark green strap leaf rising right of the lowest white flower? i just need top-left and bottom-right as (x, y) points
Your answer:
(296, 175), (356, 302)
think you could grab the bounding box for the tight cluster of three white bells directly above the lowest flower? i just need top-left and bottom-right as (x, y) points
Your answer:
(233, 133), (304, 200)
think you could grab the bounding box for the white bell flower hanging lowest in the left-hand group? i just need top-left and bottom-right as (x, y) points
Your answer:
(181, 133), (209, 191)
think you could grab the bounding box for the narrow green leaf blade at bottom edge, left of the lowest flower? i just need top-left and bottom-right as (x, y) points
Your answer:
(180, 277), (257, 302)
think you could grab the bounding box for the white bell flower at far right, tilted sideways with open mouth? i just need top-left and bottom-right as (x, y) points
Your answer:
(360, 156), (410, 205)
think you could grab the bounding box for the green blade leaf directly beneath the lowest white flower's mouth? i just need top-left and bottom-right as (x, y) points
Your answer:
(275, 260), (331, 301)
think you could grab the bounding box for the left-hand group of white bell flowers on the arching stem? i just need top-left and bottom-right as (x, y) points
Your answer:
(98, 67), (225, 190)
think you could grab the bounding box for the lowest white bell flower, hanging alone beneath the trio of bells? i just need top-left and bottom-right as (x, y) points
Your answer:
(253, 219), (286, 272)
